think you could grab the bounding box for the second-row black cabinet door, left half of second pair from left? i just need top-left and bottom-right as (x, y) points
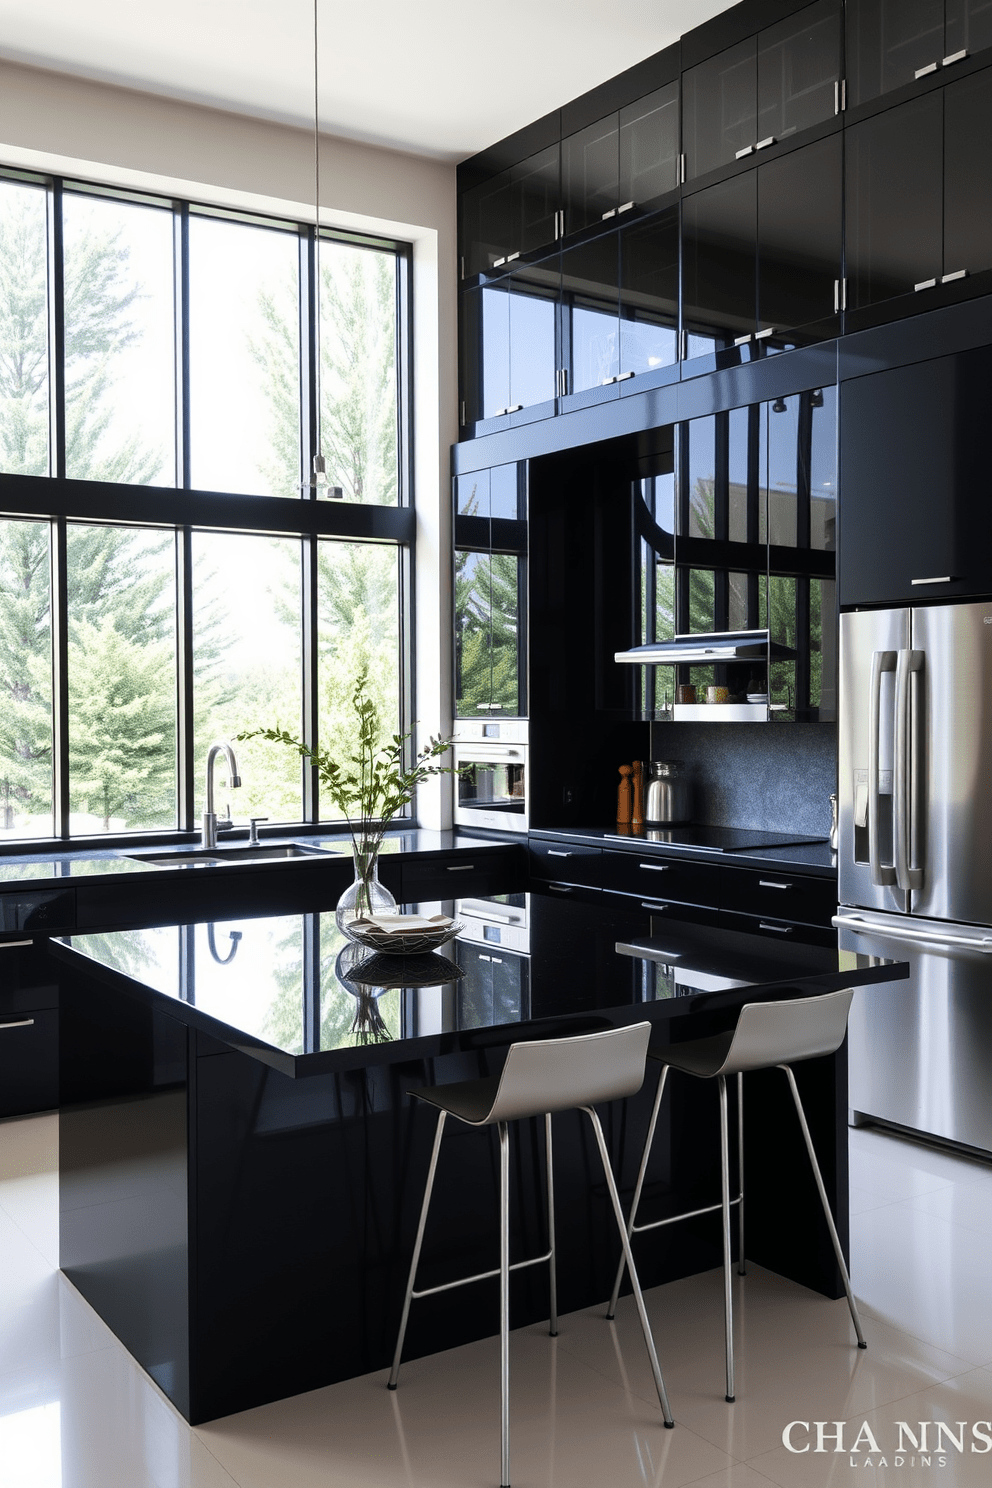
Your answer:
(561, 231), (620, 394)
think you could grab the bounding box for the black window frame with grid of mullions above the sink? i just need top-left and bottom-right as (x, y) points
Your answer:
(0, 164), (416, 856)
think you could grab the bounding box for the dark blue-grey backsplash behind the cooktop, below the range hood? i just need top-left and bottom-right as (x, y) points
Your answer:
(651, 723), (837, 836)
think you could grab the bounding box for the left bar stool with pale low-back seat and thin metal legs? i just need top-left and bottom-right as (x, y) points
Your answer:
(388, 1022), (675, 1488)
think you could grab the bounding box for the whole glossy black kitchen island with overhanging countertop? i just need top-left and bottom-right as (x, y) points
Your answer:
(51, 894), (906, 1423)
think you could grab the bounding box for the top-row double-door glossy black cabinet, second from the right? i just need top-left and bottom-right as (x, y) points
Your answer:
(683, 0), (842, 180)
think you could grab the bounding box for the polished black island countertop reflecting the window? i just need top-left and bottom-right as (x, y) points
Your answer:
(52, 894), (907, 1077)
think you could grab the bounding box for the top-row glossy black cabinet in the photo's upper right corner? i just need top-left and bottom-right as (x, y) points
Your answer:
(848, 0), (992, 107)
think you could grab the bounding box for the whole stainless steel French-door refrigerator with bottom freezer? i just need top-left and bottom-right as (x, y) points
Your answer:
(836, 603), (992, 1152)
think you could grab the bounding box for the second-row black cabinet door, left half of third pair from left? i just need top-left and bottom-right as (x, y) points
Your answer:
(683, 171), (757, 359)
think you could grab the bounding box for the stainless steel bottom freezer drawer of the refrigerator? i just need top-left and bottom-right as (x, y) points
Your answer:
(836, 909), (992, 1152)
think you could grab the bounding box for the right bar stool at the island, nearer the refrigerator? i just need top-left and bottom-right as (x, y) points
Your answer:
(607, 990), (869, 1402)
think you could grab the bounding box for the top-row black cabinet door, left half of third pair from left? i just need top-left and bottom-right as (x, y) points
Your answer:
(683, 37), (759, 180)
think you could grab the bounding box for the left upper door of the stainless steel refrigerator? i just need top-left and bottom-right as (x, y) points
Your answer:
(837, 610), (910, 911)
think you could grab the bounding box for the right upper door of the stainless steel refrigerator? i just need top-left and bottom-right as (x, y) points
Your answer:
(916, 603), (992, 922)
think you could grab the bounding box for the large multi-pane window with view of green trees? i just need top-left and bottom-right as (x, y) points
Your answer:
(0, 171), (413, 845)
